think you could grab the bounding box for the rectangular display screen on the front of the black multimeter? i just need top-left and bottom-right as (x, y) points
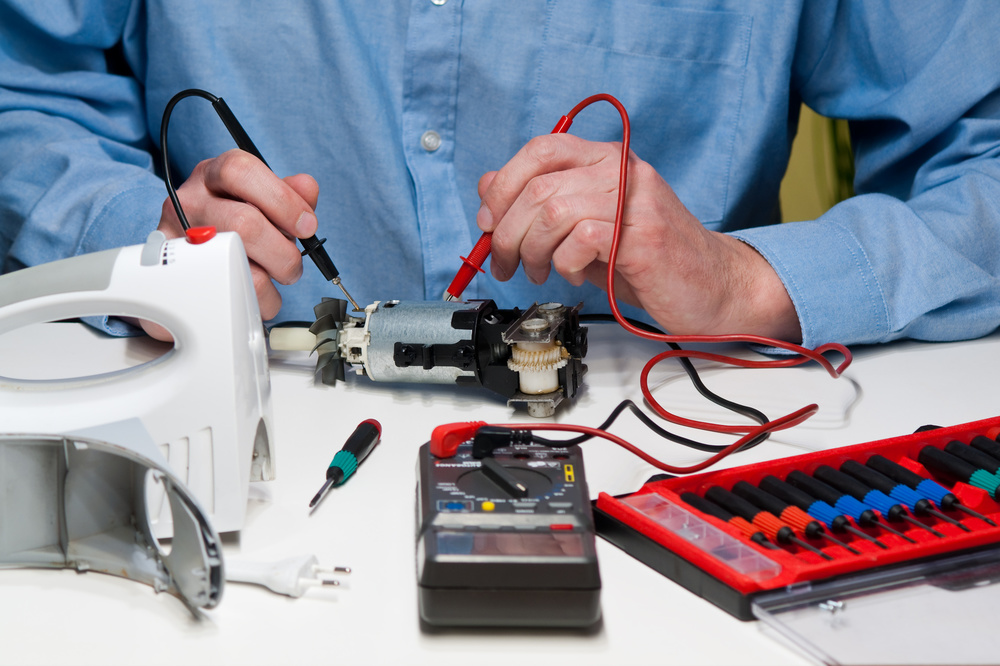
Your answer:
(437, 532), (583, 557)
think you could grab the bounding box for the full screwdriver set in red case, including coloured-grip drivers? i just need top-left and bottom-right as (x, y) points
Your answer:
(595, 417), (1000, 620)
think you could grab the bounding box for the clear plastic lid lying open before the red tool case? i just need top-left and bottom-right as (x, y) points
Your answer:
(752, 546), (1000, 666)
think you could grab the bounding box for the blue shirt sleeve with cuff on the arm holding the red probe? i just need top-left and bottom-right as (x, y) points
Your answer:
(734, 0), (1000, 347)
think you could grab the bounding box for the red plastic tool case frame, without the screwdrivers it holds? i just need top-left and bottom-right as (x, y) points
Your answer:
(594, 417), (1000, 620)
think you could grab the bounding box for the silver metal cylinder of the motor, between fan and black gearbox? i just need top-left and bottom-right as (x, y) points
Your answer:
(364, 301), (475, 384)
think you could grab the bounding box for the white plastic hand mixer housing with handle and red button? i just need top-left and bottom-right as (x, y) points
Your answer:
(0, 231), (274, 537)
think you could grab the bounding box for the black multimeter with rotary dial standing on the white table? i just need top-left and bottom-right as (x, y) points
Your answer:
(417, 442), (601, 627)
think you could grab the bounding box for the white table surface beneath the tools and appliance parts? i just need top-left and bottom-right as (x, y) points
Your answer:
(0, 323), (1000, 666)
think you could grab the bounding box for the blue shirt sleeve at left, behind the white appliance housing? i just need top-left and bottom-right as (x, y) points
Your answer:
(0, 0), (164, 271)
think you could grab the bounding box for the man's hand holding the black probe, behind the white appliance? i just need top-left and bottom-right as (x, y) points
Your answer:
(142, 149), (319, 340)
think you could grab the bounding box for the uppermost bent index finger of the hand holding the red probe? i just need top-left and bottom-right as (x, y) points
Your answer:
(477, 134), (620, 231)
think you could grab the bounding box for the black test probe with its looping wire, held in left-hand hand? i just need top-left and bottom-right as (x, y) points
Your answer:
(154, 88), (362, 312)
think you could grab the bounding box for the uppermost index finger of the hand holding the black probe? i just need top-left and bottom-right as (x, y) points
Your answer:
(199, 150), (316, 238)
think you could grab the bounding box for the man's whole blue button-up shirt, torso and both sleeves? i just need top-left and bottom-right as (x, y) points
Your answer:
(0, 0), (1000, 346)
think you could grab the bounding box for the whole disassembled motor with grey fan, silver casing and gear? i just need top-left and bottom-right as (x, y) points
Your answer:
(309, 298), (587, 416)
